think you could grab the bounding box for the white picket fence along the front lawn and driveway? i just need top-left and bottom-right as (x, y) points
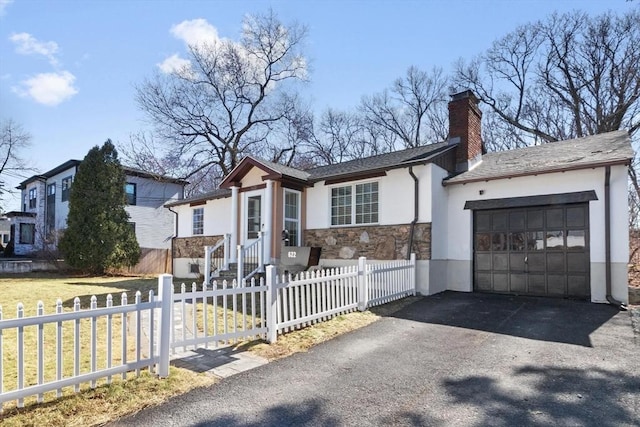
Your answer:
(0, 254), (416, 412)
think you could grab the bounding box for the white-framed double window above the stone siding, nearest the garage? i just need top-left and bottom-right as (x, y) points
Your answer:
(331, 182), (378, 225)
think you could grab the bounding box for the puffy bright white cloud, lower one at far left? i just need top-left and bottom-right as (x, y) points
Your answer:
(14, 71), (78, 106)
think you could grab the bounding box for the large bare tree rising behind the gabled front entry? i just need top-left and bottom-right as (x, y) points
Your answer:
(136, 12), (307, 186)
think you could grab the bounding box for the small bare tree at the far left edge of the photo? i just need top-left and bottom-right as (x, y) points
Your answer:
(0, 119), (33, 210)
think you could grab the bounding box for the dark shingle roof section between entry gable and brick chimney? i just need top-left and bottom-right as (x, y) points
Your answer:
(307, 142), (448, 181)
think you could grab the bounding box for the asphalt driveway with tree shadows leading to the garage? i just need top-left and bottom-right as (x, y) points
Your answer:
(114, 292), (640, 427)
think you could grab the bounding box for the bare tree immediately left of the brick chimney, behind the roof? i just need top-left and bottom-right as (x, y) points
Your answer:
(360, 66), (448, 148)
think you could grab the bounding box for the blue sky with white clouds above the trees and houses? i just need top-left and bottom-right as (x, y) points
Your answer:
(0, 0), (637, 210)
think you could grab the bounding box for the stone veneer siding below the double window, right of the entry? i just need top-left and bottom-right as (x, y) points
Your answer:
(304, 223), (431, 260)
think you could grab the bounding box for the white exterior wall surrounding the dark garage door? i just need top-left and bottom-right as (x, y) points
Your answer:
(444, 166), (629, 303)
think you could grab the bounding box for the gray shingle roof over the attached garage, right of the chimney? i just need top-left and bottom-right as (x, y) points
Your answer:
(444, 130), (633, 184)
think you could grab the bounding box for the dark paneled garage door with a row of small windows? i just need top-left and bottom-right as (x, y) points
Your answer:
(474, 203), (590, 298)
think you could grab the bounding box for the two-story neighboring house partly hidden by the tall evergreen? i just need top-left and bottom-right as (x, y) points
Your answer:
(7, 160), (186, 268)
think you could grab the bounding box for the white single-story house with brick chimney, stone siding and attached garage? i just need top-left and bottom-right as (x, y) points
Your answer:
(167, 91), (633, 303)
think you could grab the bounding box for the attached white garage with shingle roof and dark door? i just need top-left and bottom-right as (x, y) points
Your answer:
(442, 131), (633, 305)
